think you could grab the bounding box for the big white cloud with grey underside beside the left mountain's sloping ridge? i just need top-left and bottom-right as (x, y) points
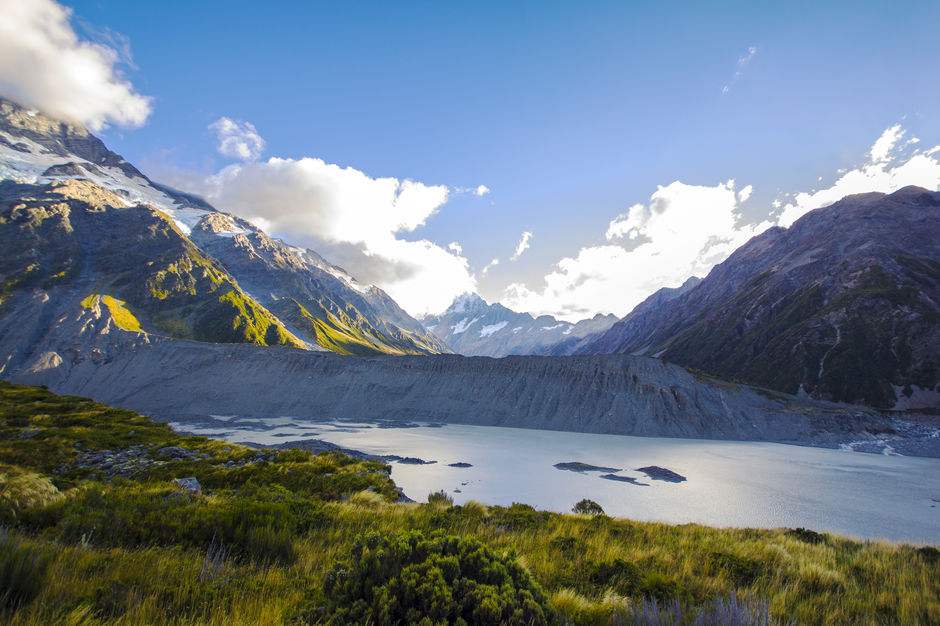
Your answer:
(181, 158), (476, 316)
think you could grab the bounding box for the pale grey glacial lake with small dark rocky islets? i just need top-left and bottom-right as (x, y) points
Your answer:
(170, 416), (940, 545)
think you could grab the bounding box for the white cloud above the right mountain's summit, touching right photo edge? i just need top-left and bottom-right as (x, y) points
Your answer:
(778, 125), (940, 226)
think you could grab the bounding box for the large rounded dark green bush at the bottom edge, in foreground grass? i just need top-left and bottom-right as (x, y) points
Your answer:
(317, 531), (552, 625)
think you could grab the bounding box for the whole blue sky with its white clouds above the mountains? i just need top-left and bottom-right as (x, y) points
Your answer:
(0, 0), (940, 321)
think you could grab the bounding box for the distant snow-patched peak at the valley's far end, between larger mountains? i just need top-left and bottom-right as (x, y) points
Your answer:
(422, 293), (617, 357)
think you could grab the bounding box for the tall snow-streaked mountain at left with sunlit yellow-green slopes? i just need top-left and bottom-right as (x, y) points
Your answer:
(0, 95), (447, 355)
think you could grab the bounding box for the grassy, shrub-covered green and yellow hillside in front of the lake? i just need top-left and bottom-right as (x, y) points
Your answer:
(0, 382), (940, 624)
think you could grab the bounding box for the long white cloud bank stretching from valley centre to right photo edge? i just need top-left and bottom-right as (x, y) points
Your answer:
(501, 126), (940, 321)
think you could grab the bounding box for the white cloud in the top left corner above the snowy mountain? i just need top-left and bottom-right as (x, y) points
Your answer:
(0, 0), (151, 131)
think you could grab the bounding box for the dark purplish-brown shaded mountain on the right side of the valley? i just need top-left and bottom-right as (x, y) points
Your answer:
(581, 187), (940, 409)
